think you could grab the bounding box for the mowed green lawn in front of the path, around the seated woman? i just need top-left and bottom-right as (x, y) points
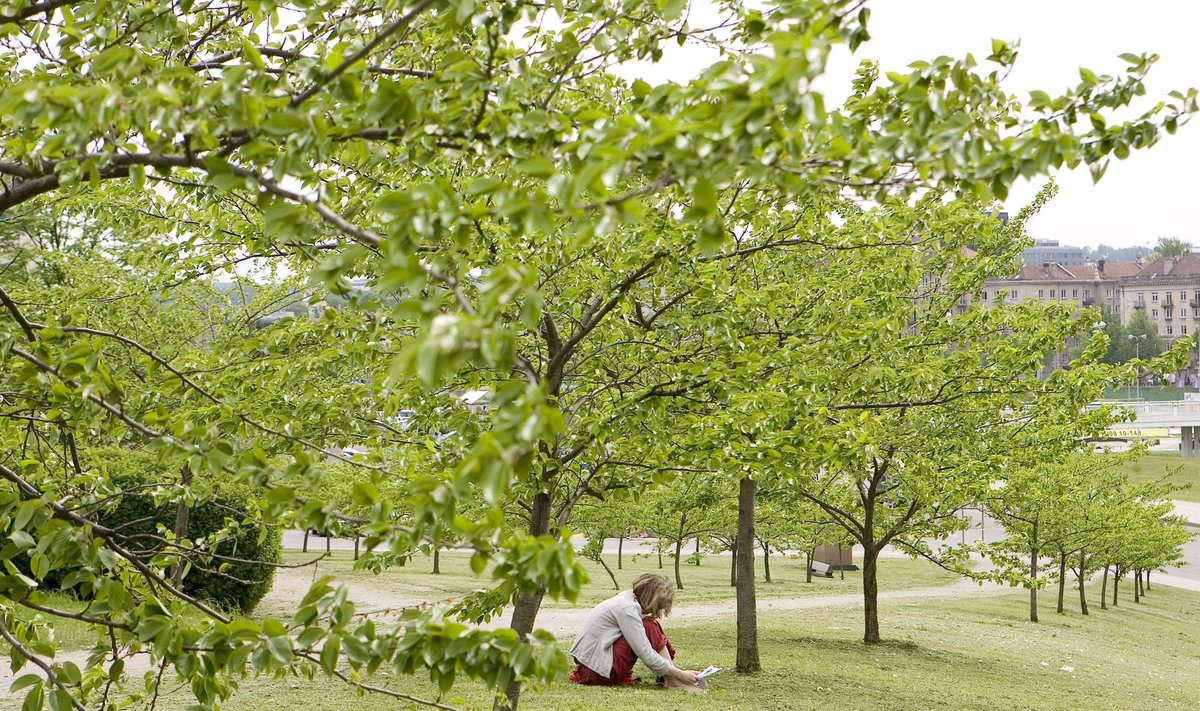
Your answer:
(158, 576), (1200, 711)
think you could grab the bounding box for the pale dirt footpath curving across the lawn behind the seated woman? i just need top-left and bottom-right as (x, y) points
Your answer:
(0, 568), (1012, 706)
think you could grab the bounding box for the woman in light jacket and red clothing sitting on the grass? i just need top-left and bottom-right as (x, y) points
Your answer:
(570, 573), (707, 691)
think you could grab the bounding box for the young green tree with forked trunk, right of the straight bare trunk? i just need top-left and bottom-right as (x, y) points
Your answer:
(700, 194), (1183, 641)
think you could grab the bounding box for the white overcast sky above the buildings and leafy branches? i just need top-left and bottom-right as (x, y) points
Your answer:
(622, 0), (1200, 246)
